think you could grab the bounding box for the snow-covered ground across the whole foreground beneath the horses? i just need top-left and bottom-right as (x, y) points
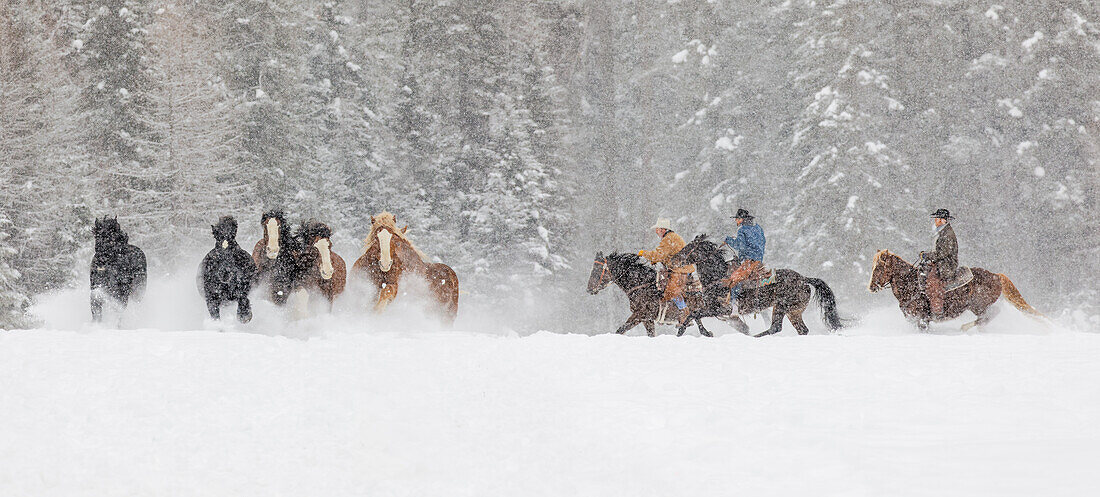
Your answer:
(0, 277), (1100, 496)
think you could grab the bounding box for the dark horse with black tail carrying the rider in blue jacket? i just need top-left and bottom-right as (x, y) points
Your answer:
(672, 234), (844, 338)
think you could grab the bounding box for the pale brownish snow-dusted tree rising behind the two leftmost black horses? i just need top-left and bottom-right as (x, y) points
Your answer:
(150, 3), (260, 247)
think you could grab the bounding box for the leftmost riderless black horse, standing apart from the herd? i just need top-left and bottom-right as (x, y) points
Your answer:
(91, 218), (149, 322)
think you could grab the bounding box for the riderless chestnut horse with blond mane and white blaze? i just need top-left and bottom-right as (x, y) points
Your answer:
(352, 212), (459, 322)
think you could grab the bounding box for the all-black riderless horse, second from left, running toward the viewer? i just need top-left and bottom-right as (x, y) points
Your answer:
(199, 216), (256, 322)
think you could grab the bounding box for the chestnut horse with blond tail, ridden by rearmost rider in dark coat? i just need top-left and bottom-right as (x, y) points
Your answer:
(868, 250), (1043, 330)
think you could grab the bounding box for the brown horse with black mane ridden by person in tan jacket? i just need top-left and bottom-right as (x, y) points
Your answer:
(589, 252), (713, 336)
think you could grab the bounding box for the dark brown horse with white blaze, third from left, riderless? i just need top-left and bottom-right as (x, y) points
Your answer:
(252, 211), (306, 306)
